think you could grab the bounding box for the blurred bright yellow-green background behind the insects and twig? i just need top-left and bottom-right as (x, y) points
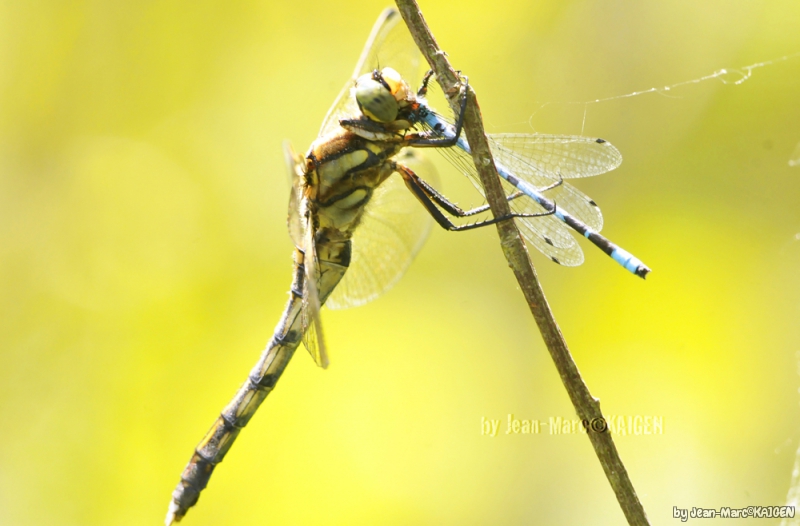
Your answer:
(0, 0), (800, 526)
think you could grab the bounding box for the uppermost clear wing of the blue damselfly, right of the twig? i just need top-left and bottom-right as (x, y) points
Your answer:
(489, 133), (622, 178)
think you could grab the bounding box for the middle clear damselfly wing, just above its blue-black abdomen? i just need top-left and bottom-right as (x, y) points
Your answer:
(492, 139), (613, 232)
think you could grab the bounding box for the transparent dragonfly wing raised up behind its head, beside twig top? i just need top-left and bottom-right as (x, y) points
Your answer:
(319, 7), (424, 136)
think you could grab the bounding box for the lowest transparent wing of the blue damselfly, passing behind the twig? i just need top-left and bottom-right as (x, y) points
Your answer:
(439, 140), (583, 267)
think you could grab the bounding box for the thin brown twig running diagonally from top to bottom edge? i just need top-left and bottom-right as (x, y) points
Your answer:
(396, 0), (649, 526)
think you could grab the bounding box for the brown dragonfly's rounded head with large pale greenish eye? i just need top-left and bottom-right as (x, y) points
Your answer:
(355, 68), (411, 123)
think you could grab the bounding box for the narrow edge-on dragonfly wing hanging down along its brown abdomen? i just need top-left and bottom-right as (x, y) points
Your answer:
(302, 224), (328, 369)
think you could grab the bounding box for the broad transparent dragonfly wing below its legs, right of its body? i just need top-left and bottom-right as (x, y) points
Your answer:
(325, 148), (439, 309)
